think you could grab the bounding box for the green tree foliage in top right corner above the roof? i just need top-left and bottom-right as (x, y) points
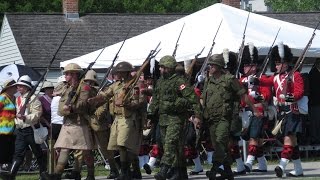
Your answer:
(264, 0), (320, 12)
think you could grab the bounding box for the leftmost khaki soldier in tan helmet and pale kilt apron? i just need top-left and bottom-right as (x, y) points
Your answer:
(46, 63), (95, 180)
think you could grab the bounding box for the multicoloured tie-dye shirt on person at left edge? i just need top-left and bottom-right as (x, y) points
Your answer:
(0, 93), (16, 135)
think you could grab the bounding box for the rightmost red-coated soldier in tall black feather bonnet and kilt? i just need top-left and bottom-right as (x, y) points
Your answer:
(260, 43), (304, 177)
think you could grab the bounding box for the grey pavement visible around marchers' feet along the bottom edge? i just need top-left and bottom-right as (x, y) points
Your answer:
(92, 161), (320, 180)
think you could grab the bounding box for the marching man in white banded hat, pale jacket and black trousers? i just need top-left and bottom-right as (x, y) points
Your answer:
(1, 75), (46, 179)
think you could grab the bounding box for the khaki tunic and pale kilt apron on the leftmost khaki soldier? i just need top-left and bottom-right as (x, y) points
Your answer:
(54, 82), (96, 150)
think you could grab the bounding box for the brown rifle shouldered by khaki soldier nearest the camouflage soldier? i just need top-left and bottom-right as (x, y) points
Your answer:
(119, 42), (161, 104)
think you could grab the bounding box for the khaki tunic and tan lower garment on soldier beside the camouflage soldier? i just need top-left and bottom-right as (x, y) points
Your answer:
(101, 81), (146, 154)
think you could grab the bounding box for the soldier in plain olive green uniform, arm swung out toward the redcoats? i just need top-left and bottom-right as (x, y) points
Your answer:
(202, 54), (257, 180)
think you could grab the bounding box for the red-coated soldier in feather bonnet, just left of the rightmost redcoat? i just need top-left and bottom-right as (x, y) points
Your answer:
(236, 43), (271, 172)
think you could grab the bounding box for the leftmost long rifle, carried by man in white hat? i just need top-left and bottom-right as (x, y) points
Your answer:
(18, 28), (71, 115)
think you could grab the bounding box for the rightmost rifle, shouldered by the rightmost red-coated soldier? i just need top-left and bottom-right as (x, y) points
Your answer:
(282, 21), (320, 96)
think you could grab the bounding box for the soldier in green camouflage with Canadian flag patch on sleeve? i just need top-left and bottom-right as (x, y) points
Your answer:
(149, 56), (201, 180)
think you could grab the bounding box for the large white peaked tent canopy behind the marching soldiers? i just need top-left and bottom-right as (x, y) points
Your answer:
(60, 3), (320, 68)
